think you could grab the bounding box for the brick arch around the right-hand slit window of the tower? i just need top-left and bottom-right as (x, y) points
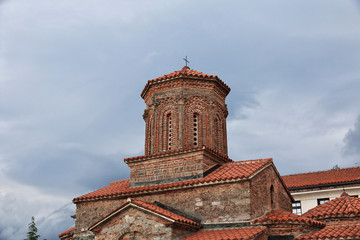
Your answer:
(184, 96), (211, 148)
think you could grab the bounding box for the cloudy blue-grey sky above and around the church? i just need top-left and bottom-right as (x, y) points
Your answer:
(0, 0), (360, 240)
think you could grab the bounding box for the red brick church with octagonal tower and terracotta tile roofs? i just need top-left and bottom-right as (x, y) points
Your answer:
(59, 66), (360, 240)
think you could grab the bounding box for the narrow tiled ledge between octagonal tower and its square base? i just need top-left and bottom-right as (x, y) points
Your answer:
(124, 145), (233, 163)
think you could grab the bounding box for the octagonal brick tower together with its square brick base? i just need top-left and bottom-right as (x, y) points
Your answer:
(131, 67), (230, 186)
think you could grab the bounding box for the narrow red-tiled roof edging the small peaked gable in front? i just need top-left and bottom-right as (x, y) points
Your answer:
(89, 198), (200, 230)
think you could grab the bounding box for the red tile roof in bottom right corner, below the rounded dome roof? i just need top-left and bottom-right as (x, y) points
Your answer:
(296, 222), (360, 240)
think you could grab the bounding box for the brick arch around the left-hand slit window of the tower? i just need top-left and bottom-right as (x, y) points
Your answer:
(153, 100), (179, 153)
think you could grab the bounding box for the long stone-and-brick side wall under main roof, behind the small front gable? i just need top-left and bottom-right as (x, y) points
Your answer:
(75, 181), (251, 232)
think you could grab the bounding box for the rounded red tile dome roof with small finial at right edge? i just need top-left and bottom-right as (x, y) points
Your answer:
(302, 192), (360, 219)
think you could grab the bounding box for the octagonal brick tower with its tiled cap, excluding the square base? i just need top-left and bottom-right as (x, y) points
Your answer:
(142, 67), (230, 155)
